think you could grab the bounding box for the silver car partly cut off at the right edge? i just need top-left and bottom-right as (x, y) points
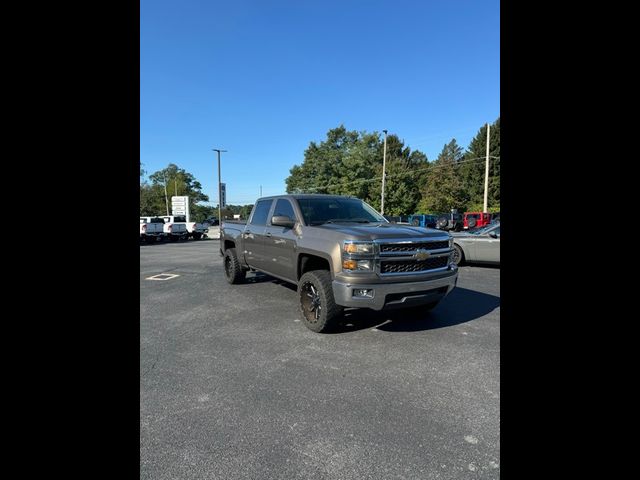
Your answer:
(450, 223), (500, 265)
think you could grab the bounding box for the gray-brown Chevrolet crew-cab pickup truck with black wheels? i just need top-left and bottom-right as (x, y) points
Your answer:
(220, 195), (458, 332)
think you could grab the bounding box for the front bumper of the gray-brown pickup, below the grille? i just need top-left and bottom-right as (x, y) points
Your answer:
(332, 268), (458, 310)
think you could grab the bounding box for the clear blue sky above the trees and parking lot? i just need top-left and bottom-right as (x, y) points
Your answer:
(140, 0), (500, 204)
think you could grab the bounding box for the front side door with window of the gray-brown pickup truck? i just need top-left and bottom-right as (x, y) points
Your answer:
(264, 198), (300, 280)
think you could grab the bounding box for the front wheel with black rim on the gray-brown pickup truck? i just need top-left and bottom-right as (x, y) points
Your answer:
(298, 270), (342, 333)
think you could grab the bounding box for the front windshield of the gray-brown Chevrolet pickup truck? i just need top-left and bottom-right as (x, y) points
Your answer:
(296, 197), (387, 225)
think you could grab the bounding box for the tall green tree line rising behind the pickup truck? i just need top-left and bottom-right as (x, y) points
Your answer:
(286, 118), (500, 215)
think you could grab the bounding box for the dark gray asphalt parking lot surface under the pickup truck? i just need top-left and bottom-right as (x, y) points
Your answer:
(140, 240), (500, 480)
